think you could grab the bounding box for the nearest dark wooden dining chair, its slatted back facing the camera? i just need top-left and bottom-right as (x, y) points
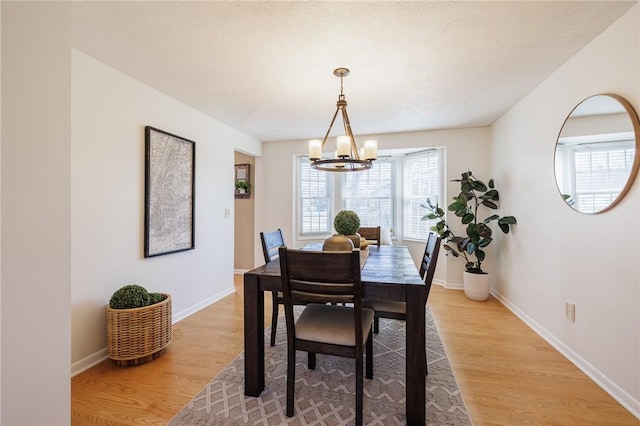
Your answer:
(279, 247), (375, 426)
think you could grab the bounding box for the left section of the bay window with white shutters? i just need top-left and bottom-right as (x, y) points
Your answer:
(298, 157), (333, 234)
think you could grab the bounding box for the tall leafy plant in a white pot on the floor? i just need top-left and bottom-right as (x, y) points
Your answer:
(422, 171), (517, 301)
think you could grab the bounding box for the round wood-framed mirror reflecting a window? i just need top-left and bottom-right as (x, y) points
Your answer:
(555, 94), (640, 213)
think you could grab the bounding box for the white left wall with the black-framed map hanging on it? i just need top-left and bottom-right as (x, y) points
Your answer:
(71, 50), (261, 372)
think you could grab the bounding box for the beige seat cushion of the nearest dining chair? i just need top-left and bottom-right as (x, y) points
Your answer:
(296, 303), (374, 346)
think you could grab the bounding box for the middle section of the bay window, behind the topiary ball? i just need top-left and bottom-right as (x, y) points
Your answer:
(342, 157), (395, 227)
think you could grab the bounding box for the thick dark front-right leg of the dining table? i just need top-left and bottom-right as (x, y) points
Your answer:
(406, 285), (427, 425)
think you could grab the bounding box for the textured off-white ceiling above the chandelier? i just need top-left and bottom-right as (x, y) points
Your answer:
(72, 1), (636, 141)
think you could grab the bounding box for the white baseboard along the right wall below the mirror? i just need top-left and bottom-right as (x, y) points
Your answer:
(491, 290), (640, 419)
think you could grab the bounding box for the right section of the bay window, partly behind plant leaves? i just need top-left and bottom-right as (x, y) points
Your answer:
(403, 149), (446, 240)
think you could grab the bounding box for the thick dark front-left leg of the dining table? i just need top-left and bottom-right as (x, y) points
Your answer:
(244, 274), (264, 396)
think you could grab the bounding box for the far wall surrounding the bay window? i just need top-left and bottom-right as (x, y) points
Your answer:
(256, 123), (491, 287)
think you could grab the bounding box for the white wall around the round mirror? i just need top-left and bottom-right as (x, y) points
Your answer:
(492, 5), (640, 416)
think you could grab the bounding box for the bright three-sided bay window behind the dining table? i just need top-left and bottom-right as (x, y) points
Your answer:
(297, 149), (442, 240)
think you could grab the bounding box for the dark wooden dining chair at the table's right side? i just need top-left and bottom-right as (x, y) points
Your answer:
(362, 232), (441, 373)
